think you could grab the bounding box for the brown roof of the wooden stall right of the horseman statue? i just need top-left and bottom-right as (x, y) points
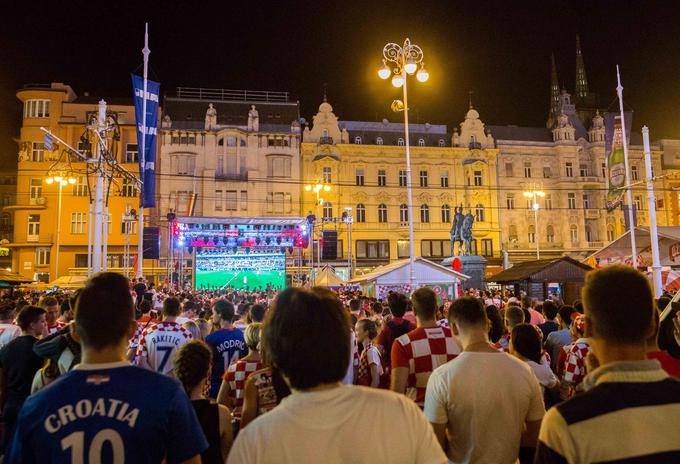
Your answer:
(487, 256), (592, 283)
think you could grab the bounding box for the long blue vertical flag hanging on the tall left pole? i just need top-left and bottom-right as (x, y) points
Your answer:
(132, 74), (161, 208)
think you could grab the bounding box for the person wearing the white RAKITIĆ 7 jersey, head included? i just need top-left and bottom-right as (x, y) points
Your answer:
(137, 297), (192, 375)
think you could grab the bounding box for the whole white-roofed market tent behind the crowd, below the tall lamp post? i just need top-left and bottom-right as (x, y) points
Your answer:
(349, 257), (470, 298)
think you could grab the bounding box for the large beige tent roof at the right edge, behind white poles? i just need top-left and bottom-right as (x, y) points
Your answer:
(586, 226), (680, 267)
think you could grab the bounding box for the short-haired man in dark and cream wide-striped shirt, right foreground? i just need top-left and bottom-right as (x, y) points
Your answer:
(535, 265), (680, 463)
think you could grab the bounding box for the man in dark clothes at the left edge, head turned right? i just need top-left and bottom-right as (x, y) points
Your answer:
(0, 306), (47, 449)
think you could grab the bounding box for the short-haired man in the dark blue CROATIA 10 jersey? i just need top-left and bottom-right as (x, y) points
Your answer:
(5, 273), (208, 464)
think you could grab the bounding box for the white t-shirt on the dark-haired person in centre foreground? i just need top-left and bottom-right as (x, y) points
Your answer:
(227, 385), (447, 464)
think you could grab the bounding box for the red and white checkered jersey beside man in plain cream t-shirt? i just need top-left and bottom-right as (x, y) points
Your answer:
(392, 327), (460, 408)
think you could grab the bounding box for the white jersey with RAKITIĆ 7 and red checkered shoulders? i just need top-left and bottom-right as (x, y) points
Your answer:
(137, 321), (193, 375)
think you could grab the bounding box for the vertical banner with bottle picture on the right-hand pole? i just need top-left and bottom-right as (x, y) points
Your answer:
(604, 111), (633, 211)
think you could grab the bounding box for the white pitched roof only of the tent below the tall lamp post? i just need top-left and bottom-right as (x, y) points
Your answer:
(350, 257), (470, 285)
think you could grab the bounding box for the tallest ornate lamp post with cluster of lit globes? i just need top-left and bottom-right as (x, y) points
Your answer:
(378, 38), (430, 292)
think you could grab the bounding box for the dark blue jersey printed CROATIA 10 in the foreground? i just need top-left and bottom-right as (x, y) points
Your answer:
(5, 363), (208, 464)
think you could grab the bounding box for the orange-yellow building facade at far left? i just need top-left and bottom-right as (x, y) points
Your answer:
(4, 83), (146, 282)
